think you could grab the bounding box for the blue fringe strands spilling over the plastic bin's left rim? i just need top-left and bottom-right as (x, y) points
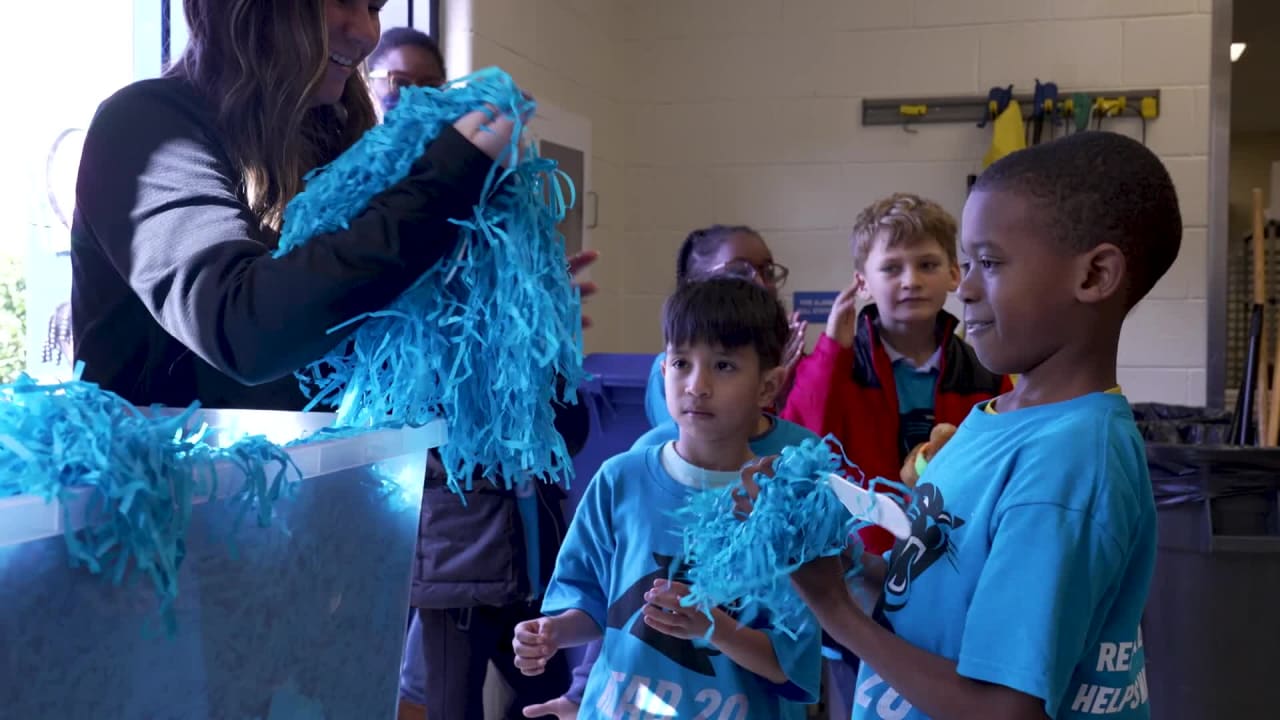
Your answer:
(0, 368), (301, 632)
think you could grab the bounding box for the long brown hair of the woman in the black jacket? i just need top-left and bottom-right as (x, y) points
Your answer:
(169, 0), (378, 232)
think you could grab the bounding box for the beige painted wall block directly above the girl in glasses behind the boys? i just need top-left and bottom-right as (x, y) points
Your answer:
(704, 165), (847, 229)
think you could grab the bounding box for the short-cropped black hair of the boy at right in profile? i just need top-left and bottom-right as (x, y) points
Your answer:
(973, 131), (1183, 307)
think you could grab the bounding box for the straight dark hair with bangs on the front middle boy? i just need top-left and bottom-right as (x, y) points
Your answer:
(662, 278), (791, 370)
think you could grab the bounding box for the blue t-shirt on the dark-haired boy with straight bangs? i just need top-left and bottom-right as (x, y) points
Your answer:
(543, 446), (820, 720)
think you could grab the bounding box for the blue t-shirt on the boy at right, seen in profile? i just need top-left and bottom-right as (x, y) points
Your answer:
(852, 393), (1156, 720)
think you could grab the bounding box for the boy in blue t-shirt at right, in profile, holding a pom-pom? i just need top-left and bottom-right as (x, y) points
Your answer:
(748, 132), (1181, 720)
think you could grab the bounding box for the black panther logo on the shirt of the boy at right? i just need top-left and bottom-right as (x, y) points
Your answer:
(877, 483), (964, 614)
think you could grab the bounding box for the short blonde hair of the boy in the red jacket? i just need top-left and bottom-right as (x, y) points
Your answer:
(850, 192), (960, 272)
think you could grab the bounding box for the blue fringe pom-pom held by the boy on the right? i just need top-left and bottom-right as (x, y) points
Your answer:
(676, 436), (867, 637)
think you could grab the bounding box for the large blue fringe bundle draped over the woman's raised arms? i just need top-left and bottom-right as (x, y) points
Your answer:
(276, 68), (584, 491)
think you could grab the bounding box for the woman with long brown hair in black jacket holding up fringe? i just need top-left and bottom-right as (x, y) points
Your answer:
(72, 0), (515, 410)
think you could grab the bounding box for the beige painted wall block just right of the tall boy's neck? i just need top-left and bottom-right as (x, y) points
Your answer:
(1120, 299), (1208, 369)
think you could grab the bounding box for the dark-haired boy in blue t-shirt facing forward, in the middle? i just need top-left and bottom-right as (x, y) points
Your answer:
(512, 278), (820, 720)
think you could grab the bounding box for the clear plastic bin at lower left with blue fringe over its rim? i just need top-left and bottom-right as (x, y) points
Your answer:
(0, 411), (444, 720)
